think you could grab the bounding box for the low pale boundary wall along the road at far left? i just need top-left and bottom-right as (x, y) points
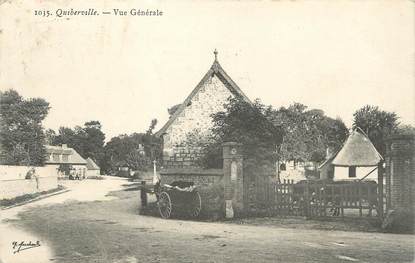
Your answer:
(0, 165), (58, 200)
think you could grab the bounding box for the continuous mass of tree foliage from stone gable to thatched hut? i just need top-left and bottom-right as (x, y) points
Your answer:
(197, 99), (348, 171)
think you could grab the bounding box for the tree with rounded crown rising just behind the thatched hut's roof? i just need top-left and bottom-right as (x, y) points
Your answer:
(353, 105), (399, 156)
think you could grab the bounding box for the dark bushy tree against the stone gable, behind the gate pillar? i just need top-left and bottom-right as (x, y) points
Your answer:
(198, 98), (283, 173)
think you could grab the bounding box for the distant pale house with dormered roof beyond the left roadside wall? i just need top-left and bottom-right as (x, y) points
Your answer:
(45, 144), (87, 178)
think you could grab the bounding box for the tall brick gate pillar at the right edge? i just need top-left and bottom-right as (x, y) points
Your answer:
(385, 135), (415, 212)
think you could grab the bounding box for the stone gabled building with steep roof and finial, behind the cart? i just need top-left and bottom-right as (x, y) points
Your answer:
(156, 50), (251, 168)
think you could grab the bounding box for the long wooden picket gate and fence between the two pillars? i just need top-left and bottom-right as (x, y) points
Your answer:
(244, 176), (380, 220)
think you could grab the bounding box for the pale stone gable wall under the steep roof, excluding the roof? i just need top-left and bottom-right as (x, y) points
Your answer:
(163, 75), (233, 168)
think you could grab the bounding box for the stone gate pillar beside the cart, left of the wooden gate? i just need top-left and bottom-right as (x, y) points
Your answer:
(222, 142), (244, 218)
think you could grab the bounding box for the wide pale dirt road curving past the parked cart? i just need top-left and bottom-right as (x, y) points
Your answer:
(1, 179), (414, 263)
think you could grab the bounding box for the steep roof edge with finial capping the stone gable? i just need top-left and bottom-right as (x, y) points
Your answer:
(155, 55), (252, 136)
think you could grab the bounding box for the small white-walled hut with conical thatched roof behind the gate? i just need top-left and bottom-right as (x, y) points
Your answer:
(319, 129), (383, 181)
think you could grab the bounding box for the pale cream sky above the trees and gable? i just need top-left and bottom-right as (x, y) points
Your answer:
(0, 0), (415, 140)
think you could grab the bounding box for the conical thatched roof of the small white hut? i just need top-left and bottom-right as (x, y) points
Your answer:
(331, 128), (383, 167)
